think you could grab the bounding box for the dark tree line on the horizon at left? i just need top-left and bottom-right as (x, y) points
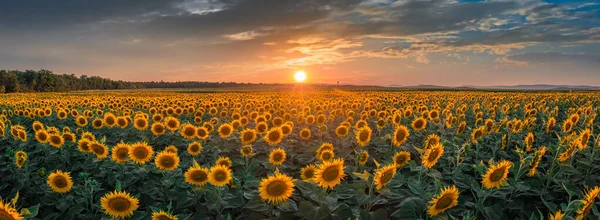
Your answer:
(0, 70), (276, 93)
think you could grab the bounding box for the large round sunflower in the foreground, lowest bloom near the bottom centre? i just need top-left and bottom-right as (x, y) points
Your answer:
(258, 172), (294, 204)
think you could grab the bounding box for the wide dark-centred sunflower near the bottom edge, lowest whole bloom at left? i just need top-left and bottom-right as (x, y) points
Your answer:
(100, 190), (140, 219)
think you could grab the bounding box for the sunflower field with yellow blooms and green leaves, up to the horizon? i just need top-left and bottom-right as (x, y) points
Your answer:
(0, 90), (600, 220)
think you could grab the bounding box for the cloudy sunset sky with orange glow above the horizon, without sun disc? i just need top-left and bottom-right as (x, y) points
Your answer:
(0, 0), (600, 86)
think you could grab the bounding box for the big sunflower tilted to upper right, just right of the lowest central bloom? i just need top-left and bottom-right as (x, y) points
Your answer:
(314, 159), (346, 189)
